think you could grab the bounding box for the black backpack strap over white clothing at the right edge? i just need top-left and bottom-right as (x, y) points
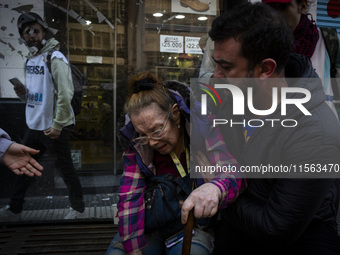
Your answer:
(320, 27), (340, 98)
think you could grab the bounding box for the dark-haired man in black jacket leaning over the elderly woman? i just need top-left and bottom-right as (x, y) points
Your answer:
(209, 3), (340, 255)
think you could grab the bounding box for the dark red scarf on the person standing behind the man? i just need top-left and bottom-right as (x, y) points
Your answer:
(293, 14), (319, 59)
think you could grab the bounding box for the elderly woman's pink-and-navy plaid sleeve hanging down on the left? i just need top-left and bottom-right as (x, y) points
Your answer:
(118, 151), (147, 254)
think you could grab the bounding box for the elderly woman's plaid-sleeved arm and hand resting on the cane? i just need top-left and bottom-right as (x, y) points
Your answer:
(182, 125), (247, 224)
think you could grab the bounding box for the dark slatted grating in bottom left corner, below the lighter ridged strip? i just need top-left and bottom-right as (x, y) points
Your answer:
(0, 222), (118, 255)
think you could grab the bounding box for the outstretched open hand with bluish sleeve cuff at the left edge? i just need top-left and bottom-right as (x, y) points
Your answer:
(0, 128), (43, 176)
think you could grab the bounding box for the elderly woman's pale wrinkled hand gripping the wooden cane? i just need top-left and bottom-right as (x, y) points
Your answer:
(181, 183), (222, 224)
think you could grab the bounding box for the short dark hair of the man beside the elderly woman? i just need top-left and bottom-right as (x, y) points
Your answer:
(209, 3), (294, 73)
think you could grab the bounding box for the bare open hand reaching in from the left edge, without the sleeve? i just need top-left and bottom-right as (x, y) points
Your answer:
(2, 143), (43, 177)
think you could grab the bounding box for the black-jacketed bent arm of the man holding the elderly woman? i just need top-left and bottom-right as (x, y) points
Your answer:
(224, 114), (340, 244)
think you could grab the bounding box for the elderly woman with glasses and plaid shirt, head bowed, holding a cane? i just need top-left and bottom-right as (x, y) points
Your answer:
(106, 72), (246, 255)
